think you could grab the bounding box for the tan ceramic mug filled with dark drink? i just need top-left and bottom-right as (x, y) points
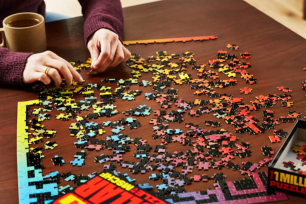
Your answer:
(0, 12), (47, 53)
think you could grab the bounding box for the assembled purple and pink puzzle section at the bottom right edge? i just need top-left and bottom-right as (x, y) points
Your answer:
(166, 172), (287, 204)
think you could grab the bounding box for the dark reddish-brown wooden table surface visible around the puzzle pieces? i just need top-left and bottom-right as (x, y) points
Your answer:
(0, 0), (306, 203)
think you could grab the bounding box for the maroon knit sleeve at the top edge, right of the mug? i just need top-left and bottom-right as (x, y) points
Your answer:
(79, 0), (123, 45)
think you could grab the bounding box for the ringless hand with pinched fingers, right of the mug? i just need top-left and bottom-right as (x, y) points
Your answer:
(87, 28), (131, 74)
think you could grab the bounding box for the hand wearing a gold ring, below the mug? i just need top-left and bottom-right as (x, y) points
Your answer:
(23, 51), (83, 87)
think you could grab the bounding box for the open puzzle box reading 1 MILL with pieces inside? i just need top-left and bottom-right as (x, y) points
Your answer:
(267, 120), (306, 197)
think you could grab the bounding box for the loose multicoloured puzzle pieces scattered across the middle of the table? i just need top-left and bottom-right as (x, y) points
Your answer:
(21, 45), (301, 203)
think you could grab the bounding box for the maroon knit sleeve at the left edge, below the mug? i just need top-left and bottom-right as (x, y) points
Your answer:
(0, 47), (32, 86)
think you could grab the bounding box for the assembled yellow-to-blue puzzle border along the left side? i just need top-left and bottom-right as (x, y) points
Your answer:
(17, 100), (58, 204)
